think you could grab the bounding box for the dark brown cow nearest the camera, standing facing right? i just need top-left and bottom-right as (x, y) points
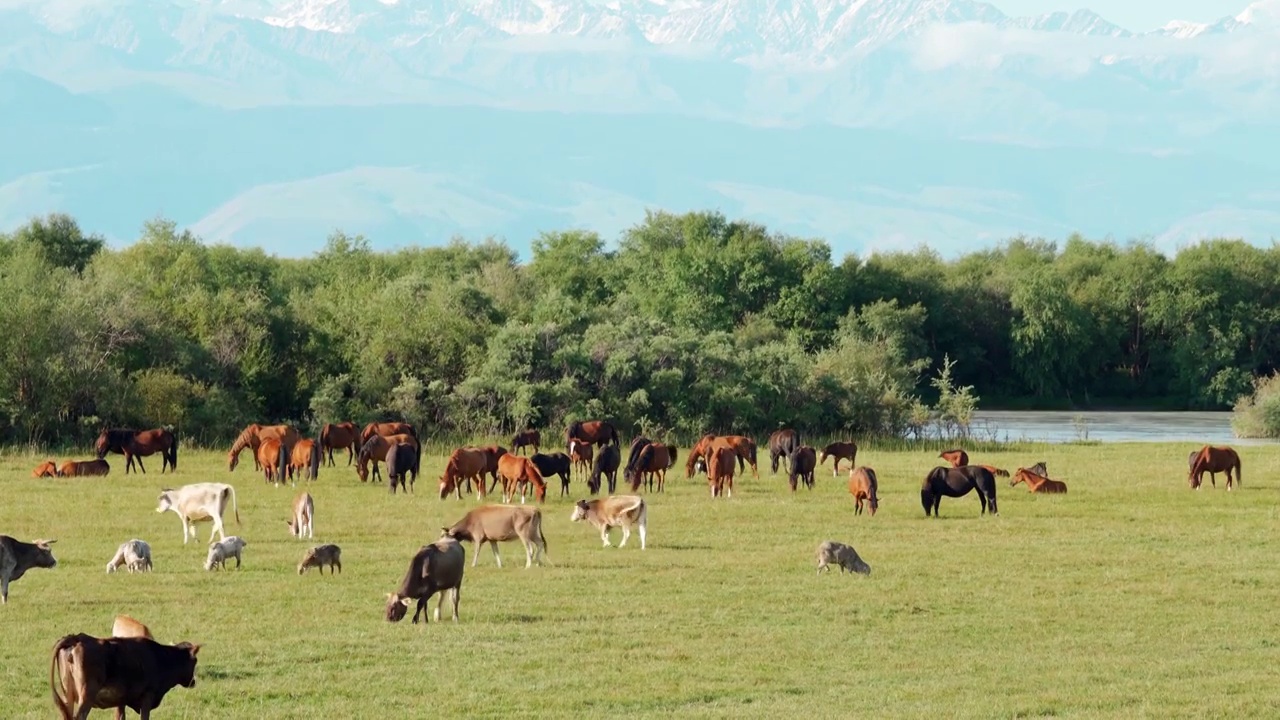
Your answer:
(49, 633), (200, 720)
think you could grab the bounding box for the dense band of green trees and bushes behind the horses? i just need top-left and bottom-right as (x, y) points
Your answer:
(0, 206), (1280, 443)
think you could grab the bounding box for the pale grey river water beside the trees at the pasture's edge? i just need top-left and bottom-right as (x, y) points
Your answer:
(972, 410), (1280, 445)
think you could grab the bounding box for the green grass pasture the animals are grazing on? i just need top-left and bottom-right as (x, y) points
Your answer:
(0, 445), (1280, 719)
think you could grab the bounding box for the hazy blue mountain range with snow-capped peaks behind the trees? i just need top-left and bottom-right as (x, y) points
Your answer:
(0, 0), (1280, 255)
